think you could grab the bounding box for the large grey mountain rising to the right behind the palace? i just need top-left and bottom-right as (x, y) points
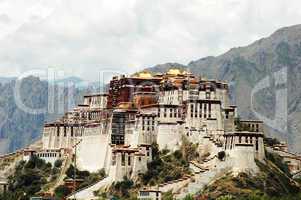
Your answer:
(149, 25), (301, 152)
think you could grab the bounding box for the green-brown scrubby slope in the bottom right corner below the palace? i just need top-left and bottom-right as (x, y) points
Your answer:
(202, 150), (301, 200)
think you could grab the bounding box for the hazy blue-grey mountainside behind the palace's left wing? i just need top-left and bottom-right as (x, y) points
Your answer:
(0, 77), (88, 155)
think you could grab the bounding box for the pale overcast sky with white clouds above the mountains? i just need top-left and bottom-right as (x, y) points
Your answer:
(0, 0), (301, 80)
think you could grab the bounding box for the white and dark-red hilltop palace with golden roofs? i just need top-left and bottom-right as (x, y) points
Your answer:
(1, 69), (300, 199)
